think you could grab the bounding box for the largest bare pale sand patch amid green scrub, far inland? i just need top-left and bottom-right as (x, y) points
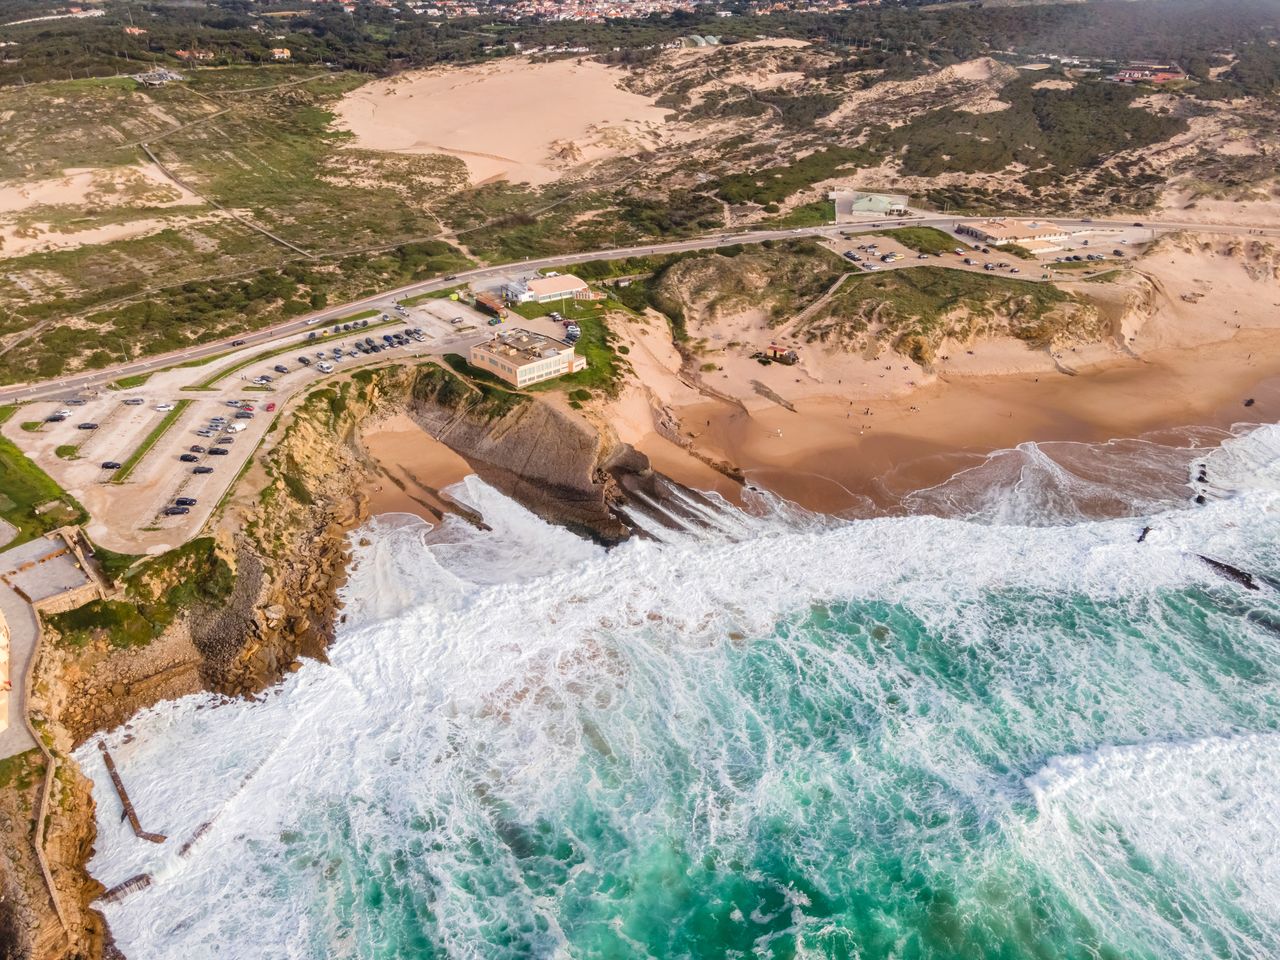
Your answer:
(337, 59), (667, 184)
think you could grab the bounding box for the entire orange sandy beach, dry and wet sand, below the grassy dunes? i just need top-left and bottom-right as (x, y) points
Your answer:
(607, 237), (1280, 513)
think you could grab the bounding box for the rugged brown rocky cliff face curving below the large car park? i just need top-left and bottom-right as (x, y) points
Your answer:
(0, 365), (660, 960)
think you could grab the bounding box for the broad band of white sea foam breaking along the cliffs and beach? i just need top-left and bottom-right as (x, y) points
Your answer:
(77, 427), (1280, 960)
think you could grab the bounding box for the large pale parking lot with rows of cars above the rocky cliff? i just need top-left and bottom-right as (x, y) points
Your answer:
(0, 298), (490, 553)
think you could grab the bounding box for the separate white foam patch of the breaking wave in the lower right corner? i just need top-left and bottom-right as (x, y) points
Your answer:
(1025, 733), (1280, 960)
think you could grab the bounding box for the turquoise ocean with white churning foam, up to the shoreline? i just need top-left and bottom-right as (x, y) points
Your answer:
(77, 426), (1280, 960)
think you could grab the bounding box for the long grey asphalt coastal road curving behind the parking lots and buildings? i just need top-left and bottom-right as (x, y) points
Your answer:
(0, 216), (1280, 403)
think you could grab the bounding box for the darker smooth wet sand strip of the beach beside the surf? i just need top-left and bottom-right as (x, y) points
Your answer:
(637, 333), (1280, 522)
